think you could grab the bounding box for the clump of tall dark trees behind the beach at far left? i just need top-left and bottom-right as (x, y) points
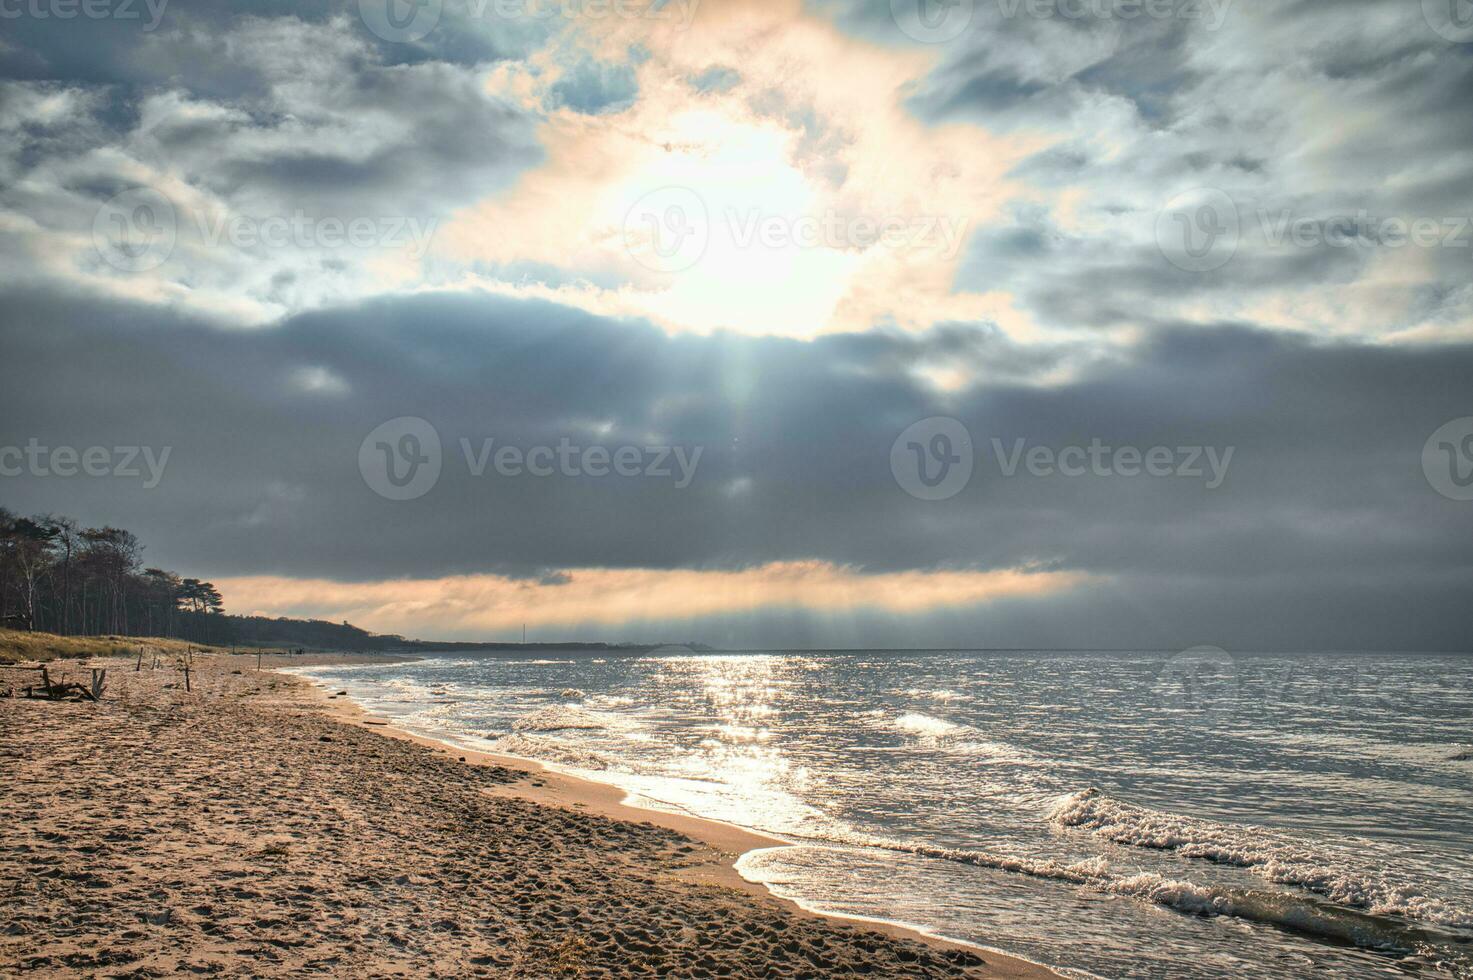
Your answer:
(0, 507), (230, 643)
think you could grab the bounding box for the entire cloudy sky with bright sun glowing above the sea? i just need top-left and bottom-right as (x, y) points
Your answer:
(0, 0), (1473, 650)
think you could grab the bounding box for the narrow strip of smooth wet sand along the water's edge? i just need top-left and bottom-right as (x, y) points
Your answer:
(281, 657), (1061, 977)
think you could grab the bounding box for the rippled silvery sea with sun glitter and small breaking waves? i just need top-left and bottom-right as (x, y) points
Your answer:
(290, 650), (1473, 977)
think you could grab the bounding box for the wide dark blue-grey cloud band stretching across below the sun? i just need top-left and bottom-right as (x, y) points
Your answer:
(0, 284), (1473, 645)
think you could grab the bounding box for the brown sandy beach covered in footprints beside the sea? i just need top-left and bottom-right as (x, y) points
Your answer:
(0, 656), (1053, 977)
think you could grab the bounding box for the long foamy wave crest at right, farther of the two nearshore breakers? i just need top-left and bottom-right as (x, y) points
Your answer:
(1050, 788), (1473, 928)
